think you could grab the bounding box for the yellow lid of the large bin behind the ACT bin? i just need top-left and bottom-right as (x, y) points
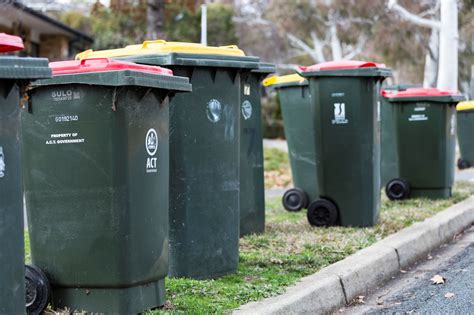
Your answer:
(76, 40), (245, 59)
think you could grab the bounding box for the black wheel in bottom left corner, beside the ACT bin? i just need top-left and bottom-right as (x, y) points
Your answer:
(25, 265), (51, 315)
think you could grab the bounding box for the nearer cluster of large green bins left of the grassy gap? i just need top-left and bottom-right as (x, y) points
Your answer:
(0, 36), (274, 314)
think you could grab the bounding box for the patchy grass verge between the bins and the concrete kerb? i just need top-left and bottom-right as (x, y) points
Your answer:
(27, 182), (474, 314)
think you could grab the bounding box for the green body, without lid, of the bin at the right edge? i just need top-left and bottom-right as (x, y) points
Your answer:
(457, 102), (474, 167)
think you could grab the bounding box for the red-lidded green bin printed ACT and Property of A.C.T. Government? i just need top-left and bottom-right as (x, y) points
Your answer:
(22, 58), (191, 314)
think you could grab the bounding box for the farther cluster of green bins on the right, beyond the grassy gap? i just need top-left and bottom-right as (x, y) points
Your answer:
(264, 61), (466, 226)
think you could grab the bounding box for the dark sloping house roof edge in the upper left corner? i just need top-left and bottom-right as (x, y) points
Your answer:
(0, 0), (94, 44)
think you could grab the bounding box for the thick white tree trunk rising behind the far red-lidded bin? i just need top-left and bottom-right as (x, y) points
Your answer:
(437, 0), (459, 91)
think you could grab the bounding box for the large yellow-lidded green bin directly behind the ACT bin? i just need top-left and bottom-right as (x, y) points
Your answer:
(77, 40), (259, 279)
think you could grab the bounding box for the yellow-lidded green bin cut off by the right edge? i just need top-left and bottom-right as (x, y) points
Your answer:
(456, 101), (474, 170)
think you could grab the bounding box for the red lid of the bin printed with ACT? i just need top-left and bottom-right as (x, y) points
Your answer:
(49, 58), (173, 75)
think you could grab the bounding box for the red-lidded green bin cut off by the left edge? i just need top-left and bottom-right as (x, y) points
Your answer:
(0, 33), (51, 314)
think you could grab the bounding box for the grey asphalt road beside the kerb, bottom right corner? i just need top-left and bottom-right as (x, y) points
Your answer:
(337, 228), (474, 314)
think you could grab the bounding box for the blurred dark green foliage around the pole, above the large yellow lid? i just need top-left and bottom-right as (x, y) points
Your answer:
(59, 0), (238, 50)
